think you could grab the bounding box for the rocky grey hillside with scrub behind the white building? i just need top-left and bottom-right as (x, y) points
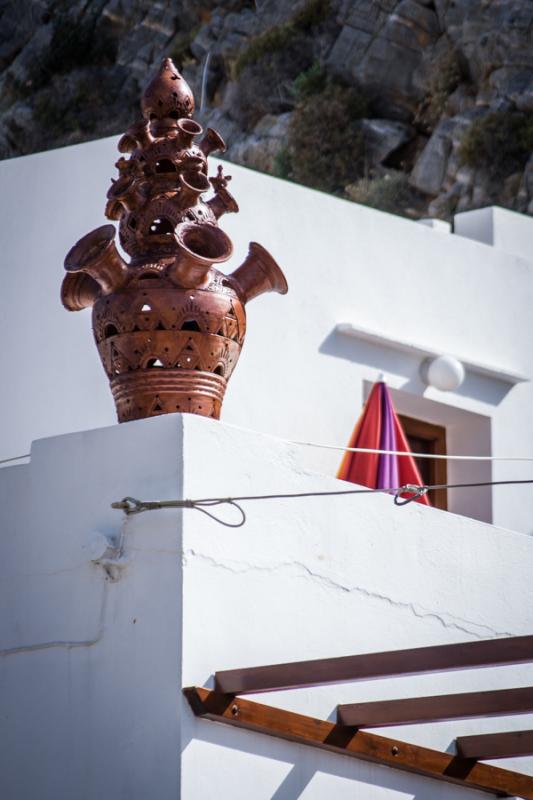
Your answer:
(0, 0), (533, 218)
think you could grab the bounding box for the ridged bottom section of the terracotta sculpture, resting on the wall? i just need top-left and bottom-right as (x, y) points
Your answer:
(110, 367), (227, 422)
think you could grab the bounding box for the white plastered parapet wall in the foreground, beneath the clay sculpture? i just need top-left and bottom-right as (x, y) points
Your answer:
(0, 414), (533, 800)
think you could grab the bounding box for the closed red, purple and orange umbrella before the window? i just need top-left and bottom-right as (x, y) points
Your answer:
(337, 382), (431, 505)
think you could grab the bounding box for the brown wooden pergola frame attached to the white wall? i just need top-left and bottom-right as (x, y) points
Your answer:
(183, 636), (533, 800)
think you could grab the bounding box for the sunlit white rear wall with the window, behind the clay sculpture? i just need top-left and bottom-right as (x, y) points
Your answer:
(0, 139), (533, 533)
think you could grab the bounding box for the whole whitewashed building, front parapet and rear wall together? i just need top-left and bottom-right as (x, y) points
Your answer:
(0, 139), (533, 800)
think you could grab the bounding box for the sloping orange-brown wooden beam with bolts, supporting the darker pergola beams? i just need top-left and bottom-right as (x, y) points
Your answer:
(183, 687), (533, 800)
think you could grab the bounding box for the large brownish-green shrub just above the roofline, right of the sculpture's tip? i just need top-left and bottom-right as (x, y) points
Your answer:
(285, 82), (367, 194)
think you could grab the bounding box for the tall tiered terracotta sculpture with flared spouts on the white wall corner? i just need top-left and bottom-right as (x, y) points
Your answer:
(61, 58), (287, 422)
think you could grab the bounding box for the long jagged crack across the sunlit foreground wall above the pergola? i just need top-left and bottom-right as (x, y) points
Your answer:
(183, 549), (515, 639)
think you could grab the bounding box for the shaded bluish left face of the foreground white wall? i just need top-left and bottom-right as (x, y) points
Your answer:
(0, 419), (186, 800)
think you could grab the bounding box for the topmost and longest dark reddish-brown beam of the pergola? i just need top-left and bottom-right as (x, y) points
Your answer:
(215, 636), (533, 694)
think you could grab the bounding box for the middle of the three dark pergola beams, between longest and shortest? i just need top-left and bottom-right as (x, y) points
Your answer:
(337, 687), (533, 728)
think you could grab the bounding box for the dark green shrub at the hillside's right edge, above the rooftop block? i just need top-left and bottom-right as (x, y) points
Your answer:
(459, 111), (533, 178)
